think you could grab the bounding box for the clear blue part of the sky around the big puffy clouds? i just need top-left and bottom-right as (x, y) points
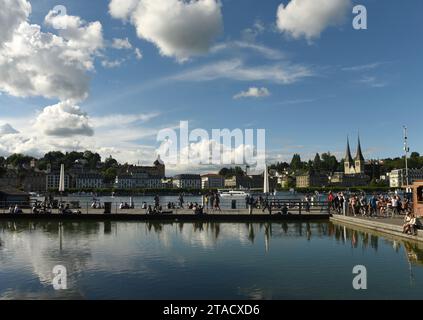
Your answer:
(0, 0), (423, 172)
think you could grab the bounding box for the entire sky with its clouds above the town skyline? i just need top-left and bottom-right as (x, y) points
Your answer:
(0, 0), (423, 173)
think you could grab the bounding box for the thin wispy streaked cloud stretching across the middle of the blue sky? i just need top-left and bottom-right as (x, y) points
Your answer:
(169, 59), (313, 84)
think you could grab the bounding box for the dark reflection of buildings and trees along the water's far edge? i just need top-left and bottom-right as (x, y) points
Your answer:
(0, 220), (423, 266)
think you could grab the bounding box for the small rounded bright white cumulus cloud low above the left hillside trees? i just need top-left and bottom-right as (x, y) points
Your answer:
(34, 101), (94, 137)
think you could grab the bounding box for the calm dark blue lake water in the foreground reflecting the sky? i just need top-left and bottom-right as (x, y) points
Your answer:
(0, 221), (423, 299)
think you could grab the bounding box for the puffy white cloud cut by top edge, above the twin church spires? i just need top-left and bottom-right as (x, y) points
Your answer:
(277, 0), (352, 40)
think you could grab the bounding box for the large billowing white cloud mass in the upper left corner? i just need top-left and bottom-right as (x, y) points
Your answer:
(0, 0), (103, 101)
